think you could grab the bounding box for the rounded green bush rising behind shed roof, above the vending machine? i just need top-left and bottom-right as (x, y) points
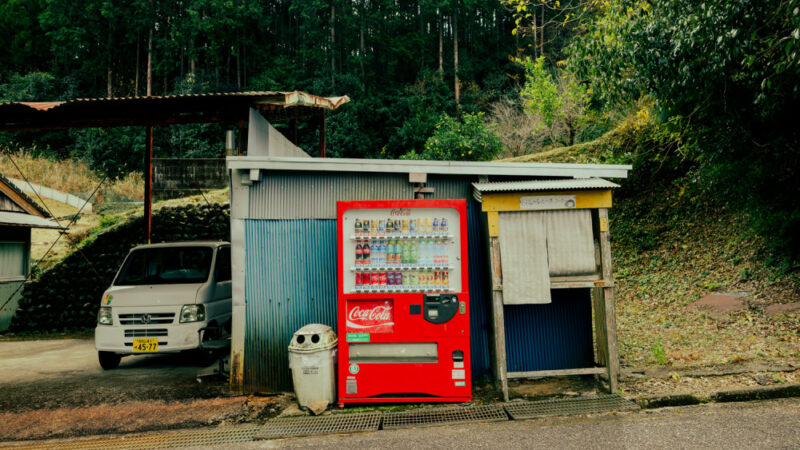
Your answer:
(403, 113), (502, 161)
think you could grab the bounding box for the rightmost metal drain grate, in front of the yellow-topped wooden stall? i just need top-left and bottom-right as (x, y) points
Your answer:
(504, 395), (639, 420)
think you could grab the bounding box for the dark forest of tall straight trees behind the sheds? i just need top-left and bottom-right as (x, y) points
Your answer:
(0, 0), (548, 173)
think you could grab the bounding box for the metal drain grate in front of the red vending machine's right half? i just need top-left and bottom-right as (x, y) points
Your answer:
(383, 405), (508, 430)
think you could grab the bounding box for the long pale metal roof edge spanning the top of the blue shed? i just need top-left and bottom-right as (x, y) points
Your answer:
(227, 156), (632, 181)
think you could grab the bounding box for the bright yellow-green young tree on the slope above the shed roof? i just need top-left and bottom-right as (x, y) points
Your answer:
(520, 56), (589, 145)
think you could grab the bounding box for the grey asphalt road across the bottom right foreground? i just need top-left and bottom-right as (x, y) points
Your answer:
(241, 399), (800, 449)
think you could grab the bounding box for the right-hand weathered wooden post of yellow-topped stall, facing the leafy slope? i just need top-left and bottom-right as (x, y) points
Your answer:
(597, 208), (619, 393)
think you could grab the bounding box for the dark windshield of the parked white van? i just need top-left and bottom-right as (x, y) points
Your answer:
(114, 247), (212, 286)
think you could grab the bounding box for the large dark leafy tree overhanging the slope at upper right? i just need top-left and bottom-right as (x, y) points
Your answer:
(569, 0), (800, 259)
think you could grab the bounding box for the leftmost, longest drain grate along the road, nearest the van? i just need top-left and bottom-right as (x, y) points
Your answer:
(15, 425), (259, 450)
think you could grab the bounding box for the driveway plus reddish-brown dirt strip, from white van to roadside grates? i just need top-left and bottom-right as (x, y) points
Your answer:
(0, 339), (279, 441)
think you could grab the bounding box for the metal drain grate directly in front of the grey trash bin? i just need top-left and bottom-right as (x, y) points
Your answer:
(253, 412), (381, 439)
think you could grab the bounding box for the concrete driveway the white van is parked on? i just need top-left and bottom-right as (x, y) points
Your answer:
(0, 339), (226, 411)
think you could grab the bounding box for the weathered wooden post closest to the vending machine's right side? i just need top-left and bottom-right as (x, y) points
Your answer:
(489, 236), (508, 402)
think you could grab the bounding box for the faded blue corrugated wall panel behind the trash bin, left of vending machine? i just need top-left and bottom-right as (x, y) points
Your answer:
(244, 219), (337, 392)
